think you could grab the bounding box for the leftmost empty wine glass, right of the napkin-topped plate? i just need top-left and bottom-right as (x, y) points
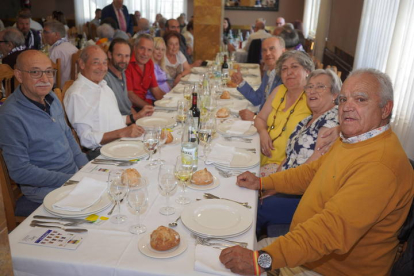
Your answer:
(108, 170), (128, 224)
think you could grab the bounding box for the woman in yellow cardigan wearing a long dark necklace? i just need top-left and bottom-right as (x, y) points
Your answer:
(255, 51), (315, 176)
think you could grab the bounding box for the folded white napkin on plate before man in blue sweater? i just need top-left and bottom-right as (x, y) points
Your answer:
(52, 177), (107, 212)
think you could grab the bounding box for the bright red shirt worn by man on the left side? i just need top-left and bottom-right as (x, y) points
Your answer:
(125, 55), (158, 104)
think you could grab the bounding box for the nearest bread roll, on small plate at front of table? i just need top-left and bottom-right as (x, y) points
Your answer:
(150, 226), (180, 251)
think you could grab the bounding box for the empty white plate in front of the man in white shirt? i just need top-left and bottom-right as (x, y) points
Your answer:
(101, 141), (147, 160)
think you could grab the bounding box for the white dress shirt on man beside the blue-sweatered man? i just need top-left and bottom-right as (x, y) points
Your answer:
(63, 73), (126, 149)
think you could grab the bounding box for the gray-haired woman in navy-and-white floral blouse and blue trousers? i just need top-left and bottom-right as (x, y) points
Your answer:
(256, 69), (342, 237)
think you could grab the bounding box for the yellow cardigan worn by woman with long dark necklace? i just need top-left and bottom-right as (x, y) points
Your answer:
(261, 84), (312, 166)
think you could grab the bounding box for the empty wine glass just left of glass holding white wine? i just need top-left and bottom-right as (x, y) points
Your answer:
(158, 164), (177, 216)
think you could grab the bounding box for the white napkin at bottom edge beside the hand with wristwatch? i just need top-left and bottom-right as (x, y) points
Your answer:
(194, 244), (235, 276)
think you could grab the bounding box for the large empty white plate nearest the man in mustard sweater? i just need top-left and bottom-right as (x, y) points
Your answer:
(181, 199), (253, 237)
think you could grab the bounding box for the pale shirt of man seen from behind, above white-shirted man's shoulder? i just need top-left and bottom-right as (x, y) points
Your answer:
(49, 38), (78, 88)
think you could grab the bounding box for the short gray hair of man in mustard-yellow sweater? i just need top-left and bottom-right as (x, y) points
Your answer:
(348, 68), (394, 108)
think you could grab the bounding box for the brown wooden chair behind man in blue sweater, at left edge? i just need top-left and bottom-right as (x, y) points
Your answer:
(0, 150), (25, 231)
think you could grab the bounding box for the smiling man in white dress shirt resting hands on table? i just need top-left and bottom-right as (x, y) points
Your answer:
(64, 45), (152, 153)
